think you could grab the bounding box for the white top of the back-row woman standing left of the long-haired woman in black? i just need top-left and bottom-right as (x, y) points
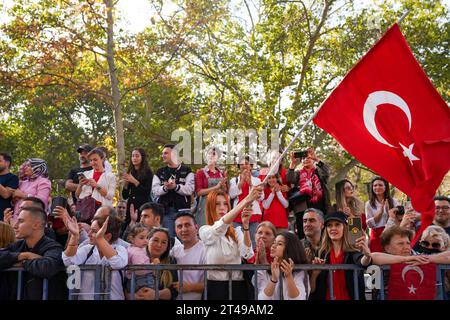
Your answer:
(78, 169), (116, 206)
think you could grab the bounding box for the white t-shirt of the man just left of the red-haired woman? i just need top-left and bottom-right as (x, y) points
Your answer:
(171, 240), (206, 300)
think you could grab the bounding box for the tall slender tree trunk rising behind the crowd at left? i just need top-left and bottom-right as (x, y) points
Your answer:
(104, 0), (125, 172)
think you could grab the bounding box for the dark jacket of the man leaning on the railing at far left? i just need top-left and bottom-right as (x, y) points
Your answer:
(0, 236), (68, 300)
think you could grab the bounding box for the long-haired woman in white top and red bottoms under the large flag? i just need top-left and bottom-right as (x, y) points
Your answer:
(365, 177), (397, 252)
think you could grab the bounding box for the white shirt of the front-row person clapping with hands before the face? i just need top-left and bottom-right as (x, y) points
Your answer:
(62, 244), (128, 300)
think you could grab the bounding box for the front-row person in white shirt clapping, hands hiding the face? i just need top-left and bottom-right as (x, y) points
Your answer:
(62, 214), (128, 300)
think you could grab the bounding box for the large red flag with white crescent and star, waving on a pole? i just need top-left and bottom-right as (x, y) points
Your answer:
(314, 24), (450, 242)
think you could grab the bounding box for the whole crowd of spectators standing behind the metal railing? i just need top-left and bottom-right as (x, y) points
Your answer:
(0, 144), (450, 300)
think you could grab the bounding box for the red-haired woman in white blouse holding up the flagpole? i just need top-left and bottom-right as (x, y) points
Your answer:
(199, 186), (262, 300)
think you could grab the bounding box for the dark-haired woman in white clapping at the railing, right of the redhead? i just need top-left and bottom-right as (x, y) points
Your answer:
(253, 231), (310, 300)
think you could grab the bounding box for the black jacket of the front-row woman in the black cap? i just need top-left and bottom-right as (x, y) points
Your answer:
(309, 251), (366, 300)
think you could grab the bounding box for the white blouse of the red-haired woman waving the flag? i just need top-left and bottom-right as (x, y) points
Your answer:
(199, 218), (253, 281)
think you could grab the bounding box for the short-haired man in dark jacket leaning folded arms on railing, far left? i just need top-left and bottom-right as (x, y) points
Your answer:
(0, 207), (68, 300)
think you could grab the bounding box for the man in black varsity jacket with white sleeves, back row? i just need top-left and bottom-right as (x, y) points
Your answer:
(152, 145), (195, 237)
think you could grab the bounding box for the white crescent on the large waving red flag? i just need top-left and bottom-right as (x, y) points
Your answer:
(363, 91), (411, 148)
